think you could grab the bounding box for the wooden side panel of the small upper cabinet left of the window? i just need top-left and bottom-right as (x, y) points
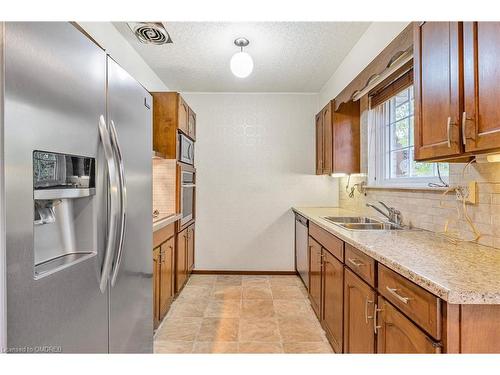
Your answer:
(332, 100), (360, 174)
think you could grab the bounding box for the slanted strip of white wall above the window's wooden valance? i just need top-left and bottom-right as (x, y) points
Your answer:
(319, 22), (409, 108)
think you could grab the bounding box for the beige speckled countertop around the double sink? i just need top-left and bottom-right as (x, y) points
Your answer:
(293, 207), (500, 304)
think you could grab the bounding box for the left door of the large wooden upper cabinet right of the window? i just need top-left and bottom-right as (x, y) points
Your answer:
(414, 22), (463, 160)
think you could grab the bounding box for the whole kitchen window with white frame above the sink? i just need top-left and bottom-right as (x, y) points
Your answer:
(368, 85), (449, 188)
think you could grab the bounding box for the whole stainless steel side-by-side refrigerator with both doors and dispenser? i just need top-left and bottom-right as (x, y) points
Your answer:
(3, 22), (153, 353)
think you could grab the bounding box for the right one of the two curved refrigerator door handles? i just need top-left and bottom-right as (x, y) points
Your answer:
(110, 120), (127, 286)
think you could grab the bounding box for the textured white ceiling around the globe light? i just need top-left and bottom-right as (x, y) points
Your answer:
(114, 22), (370, 92)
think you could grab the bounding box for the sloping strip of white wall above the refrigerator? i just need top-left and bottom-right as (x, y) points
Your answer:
(78, 22), (168, 91)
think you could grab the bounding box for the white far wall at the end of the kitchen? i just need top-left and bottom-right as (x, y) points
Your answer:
(183, 93), (338, 271)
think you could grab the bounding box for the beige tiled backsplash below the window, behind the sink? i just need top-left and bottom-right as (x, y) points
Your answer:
(339, 163), (500, 248)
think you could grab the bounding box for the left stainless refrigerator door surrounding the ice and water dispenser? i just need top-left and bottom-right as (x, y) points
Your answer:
(5, 22), (108, 352)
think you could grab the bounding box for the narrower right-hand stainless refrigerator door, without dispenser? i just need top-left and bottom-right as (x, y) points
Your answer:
(108, 58), (153, 353)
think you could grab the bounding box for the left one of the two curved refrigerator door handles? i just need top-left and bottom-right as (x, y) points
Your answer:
(99, 115), (119, 293)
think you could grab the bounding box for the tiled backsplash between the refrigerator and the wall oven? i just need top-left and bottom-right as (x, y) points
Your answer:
(153, 159), (176, 217)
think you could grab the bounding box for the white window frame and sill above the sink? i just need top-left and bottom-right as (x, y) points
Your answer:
(367, 85), (449, 189)
